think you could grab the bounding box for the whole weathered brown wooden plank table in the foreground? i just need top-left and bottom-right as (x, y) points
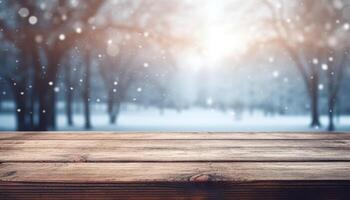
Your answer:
(0, 132), (350, 200)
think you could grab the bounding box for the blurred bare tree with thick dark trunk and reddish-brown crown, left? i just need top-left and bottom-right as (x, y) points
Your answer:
(0, 0), (103, 130)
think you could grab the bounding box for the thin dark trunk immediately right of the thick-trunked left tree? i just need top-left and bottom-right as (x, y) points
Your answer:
(65, 65), (73, 126)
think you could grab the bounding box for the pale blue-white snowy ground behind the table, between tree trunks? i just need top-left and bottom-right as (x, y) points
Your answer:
(0, 108), (350, 131)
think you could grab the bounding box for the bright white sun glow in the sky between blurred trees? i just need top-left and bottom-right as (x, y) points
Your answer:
(186, 0), (258, 70)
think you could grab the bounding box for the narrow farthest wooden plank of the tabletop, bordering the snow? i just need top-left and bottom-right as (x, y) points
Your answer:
(0, 132), (350, 140)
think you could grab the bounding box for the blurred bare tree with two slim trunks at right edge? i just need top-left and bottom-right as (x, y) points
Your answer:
(264, 0), (349, 130)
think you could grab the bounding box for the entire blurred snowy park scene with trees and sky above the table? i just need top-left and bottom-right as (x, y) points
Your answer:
(0, 0), (350, 131)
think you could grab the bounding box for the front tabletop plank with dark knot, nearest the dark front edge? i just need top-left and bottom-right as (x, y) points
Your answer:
(0, 162), (350, 183)
